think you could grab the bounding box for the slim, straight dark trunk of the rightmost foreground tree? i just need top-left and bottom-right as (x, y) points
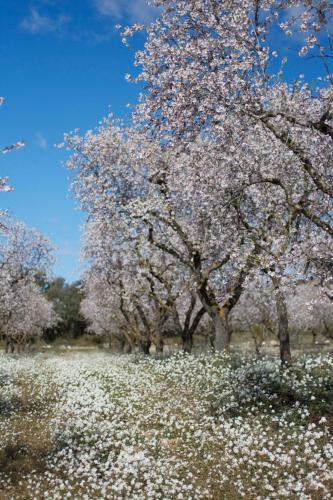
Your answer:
(271, 276), (291, 365)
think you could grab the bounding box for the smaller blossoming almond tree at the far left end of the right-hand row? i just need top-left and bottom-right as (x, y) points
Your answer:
(82, 214), (152, 353)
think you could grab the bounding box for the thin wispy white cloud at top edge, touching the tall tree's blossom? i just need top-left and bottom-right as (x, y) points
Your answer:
(93, 0), (158, 24)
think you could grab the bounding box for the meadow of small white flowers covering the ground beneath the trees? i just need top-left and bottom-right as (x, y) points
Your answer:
(0, 352), (333, 500)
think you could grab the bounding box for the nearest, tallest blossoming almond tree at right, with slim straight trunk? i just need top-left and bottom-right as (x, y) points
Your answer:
(123, 0), (333, 362)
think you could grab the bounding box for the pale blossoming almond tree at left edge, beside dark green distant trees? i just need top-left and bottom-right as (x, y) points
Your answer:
(0, 217), (57, 350)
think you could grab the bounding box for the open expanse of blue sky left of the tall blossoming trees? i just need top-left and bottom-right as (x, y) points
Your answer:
(0, 0), (158, 281)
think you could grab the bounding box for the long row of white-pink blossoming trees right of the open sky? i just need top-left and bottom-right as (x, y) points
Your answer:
(65, 0), (333, 363)
